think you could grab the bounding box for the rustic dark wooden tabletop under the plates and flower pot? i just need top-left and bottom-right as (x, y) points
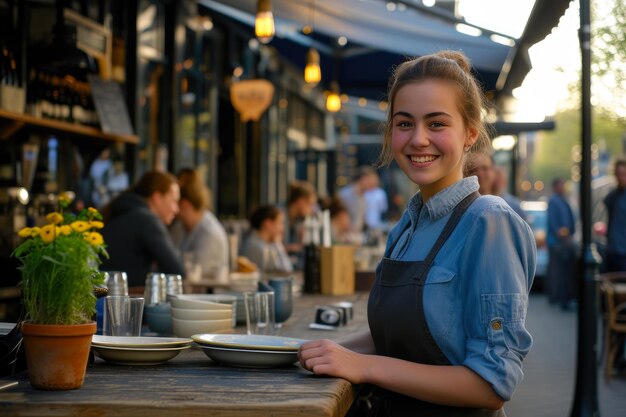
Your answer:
(0, 293), (367, 417)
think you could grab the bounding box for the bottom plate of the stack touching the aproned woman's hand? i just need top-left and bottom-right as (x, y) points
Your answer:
(200, 345), (298, 368)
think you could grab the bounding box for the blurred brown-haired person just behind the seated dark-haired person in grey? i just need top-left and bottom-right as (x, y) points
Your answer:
(284, 181), (317, 265)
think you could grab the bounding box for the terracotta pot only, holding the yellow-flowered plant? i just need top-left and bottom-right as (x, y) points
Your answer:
(22, 322), (96, 390)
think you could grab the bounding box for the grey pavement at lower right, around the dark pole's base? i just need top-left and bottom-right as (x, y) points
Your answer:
(505, 293), (626, 417)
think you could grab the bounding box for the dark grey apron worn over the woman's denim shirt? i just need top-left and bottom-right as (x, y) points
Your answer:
(368, 192), (505, 417)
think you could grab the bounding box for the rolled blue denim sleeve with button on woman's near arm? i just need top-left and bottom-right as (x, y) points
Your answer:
(460, 200), (536, 401)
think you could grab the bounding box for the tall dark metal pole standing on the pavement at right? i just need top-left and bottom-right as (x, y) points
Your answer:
(571, 0), (600, 417)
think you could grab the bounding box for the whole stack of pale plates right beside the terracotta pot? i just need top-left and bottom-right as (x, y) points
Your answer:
(91, 335), (192, 365)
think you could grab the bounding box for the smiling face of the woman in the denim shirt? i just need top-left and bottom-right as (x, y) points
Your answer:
(391, 79), (478, 200)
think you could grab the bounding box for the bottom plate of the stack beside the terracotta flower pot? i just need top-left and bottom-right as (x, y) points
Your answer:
(92, 345), (191, 365)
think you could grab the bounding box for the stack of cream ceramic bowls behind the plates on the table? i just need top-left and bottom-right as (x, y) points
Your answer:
(170, 294), (237, 337)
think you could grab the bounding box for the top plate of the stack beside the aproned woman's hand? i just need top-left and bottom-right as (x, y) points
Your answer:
(191, 334), (307, 352)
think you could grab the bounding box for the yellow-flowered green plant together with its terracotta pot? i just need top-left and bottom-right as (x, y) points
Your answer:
(12, 194), (108, 390)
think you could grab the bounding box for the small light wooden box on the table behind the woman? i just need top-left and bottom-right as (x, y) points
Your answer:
(320, 245), (354, 295)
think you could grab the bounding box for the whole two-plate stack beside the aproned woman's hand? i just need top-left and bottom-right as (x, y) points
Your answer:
(191, 334), (306, 368)
